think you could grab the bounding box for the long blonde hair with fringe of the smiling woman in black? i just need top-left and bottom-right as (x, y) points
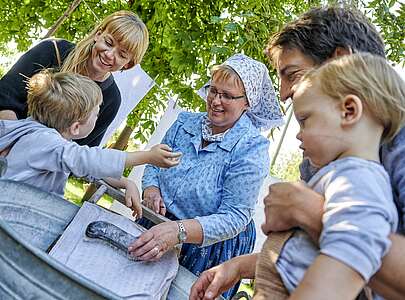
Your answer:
(61, 10), (149, 75)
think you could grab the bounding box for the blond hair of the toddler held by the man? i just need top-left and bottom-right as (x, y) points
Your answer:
(300, 53), (405, 142)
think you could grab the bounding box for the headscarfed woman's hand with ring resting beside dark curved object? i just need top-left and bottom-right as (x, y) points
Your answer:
(128, 221), (179, 261)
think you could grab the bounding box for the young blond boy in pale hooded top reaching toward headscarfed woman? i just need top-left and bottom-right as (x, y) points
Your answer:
(0, 70), (181, 217)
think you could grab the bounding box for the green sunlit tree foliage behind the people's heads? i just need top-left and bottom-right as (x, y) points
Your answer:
(0, 0), (405, 141)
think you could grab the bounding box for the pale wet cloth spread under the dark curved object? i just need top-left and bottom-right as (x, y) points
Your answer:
(50, 202), (178, 300)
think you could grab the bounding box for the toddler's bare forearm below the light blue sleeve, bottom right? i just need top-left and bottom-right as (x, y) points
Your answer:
(289, 254), (365, 300)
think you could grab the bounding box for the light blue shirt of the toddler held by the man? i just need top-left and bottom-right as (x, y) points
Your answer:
(276, 157), (398, 292)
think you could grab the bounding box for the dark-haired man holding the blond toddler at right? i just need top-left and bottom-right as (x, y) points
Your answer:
(190, 7), (405, 299)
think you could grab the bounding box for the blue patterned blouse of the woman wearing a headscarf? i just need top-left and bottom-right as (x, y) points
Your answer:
(142, 113), (269, 246)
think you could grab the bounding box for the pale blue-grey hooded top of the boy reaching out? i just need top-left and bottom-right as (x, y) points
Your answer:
(0, 118), (127, 196)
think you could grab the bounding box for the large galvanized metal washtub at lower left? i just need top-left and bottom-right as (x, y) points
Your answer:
(0, 179), (196, 300)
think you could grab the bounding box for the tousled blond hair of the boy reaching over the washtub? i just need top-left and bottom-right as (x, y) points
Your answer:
(27, 70), (103, 133)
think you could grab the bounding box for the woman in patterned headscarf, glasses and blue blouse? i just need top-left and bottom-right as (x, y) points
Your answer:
(129, 54), (282, 296)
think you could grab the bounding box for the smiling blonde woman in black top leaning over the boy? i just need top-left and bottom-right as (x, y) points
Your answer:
(0, 11), (149, 146)
